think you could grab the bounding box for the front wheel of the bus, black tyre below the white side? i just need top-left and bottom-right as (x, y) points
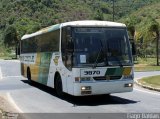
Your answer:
(55, 74), (64, 97)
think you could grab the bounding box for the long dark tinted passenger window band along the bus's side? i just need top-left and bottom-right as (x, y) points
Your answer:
(21, 30), (60, 53)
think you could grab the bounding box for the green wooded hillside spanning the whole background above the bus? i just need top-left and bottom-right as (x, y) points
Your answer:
(0, 0), (160, 57)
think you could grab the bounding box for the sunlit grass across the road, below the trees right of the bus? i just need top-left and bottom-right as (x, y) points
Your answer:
(134, 58), (160, 71)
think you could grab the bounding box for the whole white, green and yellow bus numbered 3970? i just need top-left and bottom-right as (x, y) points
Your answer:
(20, 20), (134, 96)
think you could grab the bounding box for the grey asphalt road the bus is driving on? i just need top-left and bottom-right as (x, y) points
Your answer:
(0, 60), (160, 118)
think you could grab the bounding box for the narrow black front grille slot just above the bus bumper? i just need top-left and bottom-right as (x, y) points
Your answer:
(93, 76), (122, 81)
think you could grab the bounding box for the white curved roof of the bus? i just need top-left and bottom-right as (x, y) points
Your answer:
(21, 20), (126, 40)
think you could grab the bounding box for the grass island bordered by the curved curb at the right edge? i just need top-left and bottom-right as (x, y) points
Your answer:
(139, 75), (160, 88)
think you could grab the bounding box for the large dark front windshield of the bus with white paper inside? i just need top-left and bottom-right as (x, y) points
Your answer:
(71, 27), (132, 67)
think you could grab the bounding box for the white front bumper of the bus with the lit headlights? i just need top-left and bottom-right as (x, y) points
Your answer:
(73, 80), (134, 96)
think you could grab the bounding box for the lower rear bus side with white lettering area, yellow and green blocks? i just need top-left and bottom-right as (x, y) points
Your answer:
(21, 52), (52, 85)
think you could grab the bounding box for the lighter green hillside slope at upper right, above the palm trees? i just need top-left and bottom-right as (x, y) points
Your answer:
(119, 2), (160, 40)
